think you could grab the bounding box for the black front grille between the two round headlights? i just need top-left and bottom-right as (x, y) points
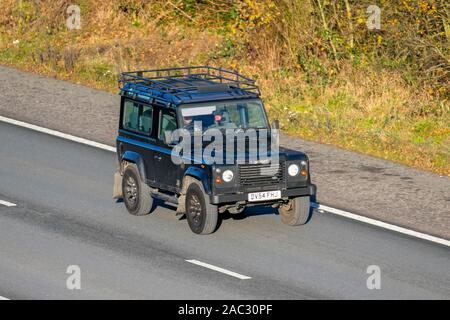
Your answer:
(239, 164), (284, 186)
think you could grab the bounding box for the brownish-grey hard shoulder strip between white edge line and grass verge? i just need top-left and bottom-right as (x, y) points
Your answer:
(0, 66), (450, 240)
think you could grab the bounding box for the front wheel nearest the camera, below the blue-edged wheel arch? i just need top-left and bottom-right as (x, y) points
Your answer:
(186, 180), (218, 234)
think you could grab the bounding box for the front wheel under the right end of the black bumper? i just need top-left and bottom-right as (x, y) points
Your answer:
(278, 196), (312, 226)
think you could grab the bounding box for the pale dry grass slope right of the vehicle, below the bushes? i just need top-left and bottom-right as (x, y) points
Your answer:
(260, 64), (450, 175)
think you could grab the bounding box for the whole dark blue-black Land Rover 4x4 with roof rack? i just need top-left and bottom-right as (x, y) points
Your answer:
(114, 66), (316, 234)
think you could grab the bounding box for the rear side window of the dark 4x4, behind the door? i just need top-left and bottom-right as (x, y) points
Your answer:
(122, 100), (153, 135)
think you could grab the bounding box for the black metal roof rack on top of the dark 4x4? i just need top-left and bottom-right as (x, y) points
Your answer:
(119, 66), (260, 95)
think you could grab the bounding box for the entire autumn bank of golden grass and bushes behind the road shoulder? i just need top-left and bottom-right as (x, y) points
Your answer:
(0, 0), (450, 174)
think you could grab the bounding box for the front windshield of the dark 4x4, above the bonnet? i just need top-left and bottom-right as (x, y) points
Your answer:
(181, 99), (268, 130)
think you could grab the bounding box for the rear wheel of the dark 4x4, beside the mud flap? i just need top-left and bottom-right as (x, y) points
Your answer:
(122, 164), (153, 216)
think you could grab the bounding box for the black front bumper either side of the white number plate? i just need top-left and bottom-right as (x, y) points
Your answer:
(209, 184), (317, 204)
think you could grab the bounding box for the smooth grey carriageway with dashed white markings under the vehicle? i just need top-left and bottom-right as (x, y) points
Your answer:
(0, 123), (450, 299)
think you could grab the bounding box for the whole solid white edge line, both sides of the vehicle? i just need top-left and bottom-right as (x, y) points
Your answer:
(0, 116), (450, 247)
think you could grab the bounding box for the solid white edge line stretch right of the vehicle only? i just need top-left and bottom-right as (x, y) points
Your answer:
(311, 203), (450, 247)
